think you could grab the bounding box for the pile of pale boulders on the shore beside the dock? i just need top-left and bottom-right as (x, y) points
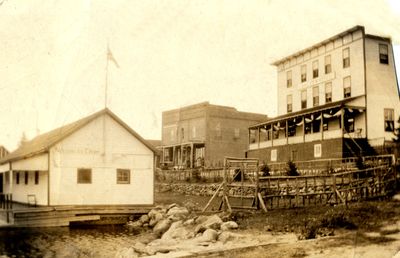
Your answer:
(116, 204), (240, 257)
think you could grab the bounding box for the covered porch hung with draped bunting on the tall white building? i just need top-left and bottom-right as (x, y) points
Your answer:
(249, 103), (366, 156)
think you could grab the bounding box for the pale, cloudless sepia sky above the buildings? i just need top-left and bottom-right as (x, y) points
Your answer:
(0, 0), (400, 150)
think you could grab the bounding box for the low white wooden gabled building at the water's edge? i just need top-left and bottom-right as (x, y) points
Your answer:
(0, 109), (155, 206)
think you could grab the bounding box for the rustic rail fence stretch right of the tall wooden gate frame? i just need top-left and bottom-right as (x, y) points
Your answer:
(259, 166), (396, 209)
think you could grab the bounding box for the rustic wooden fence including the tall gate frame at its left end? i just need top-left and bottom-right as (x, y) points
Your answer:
(203, 157), (398, 212)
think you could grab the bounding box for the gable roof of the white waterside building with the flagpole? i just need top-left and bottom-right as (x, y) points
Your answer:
(0, 108), (157, 164)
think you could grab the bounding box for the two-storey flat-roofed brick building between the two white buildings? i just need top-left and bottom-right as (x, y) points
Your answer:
(161, 102), (267, 168)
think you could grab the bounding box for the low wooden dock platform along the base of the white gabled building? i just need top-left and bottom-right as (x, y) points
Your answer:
(3, 206), (152, 227)
